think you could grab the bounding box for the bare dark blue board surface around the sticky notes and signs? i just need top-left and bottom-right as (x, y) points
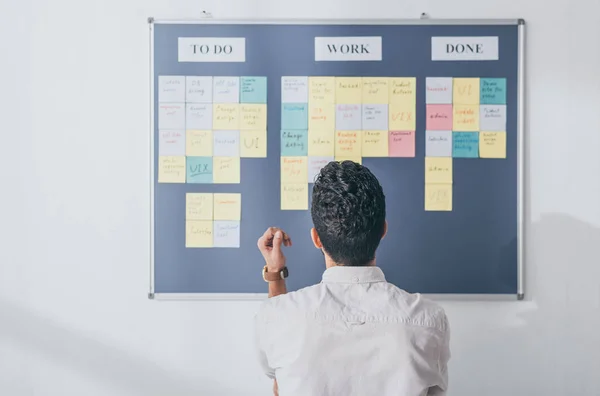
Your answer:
(153, 23), (518, 294)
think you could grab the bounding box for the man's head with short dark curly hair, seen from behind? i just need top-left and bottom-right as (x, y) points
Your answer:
(311, 161), (387, 266)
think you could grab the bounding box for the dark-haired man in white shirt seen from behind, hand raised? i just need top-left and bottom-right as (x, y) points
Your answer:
(256, 161), (450, 396)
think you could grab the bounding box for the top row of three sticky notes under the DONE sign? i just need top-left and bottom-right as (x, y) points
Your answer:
(425, 77), (506, 105)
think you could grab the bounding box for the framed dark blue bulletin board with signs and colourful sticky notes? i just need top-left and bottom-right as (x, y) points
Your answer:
(149, 19), (525, 299)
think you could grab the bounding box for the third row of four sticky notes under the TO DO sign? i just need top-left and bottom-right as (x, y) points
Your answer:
(158, 129), (267, 158)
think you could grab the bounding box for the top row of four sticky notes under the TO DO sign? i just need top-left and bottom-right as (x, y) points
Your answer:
(158, 76), (267, 103)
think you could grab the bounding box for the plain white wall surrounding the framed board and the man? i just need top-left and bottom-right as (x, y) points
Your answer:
(0, 0), (600, 396)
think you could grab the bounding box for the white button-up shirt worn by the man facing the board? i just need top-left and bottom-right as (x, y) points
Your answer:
(256, 267), (450, 396)
